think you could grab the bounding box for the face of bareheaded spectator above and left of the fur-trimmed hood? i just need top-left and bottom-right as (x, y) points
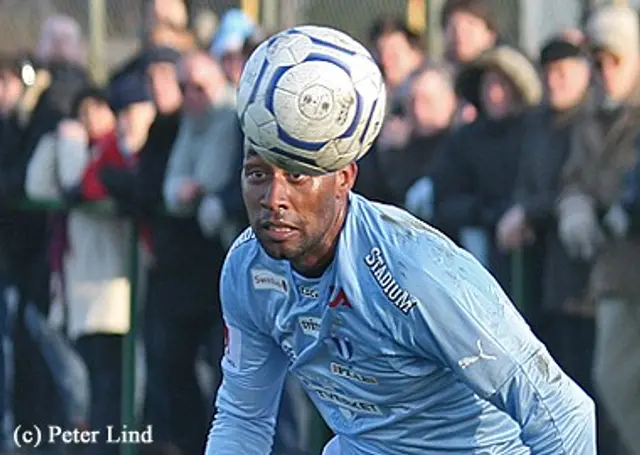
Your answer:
(444, 11), (496, 63)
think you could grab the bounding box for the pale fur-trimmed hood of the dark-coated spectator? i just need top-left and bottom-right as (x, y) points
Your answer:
(456, 44), (542, 107)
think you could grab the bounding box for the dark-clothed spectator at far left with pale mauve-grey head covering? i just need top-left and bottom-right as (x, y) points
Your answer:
(8, 15), (89, 434)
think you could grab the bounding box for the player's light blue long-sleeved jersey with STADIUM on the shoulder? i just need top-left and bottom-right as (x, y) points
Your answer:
(206, 194), (596, 455)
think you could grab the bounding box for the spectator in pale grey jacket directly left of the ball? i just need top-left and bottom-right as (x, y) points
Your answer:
(159, 53), (244, 453)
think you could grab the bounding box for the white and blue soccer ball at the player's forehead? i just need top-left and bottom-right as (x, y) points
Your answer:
(238, 26), (386, 175)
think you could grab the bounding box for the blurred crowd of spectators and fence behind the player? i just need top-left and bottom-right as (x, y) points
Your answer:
(0, 0), (640, 455)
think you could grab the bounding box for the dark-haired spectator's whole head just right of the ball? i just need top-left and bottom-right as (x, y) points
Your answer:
(370, 17), (424, 90)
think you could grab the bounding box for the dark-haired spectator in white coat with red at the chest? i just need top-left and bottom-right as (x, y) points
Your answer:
(26, 88), (131, 455)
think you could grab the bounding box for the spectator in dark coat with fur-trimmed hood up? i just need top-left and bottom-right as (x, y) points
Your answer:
(433, 45), (542, 290)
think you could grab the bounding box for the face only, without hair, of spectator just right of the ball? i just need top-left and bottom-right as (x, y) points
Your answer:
(376, 32), (422, 89)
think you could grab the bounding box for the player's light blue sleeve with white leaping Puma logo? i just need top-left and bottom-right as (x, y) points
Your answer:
(409, 254), (596, 455)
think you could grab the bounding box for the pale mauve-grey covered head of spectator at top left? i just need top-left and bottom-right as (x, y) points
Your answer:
(36, 15), (86, 64)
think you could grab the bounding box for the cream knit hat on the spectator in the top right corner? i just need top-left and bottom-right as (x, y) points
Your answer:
(586, 6), (640, 57)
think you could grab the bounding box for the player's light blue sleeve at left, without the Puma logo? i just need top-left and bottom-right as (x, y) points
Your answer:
(205, 257), (287, 455)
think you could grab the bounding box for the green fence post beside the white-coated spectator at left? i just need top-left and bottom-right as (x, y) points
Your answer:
(120, 221), (139, 455)
